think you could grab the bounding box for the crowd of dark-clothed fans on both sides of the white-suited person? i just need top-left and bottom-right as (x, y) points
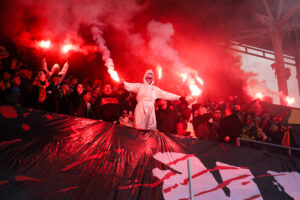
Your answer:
(0, 50), (286, 147)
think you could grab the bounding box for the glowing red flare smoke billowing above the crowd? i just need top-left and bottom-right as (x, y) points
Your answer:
(0, 0), (255, 101)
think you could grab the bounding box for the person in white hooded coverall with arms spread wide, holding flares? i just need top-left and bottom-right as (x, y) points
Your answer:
(124, 70), (180, 131)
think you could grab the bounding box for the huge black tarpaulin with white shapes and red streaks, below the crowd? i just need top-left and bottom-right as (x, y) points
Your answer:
(0, 106), (300, 200)
